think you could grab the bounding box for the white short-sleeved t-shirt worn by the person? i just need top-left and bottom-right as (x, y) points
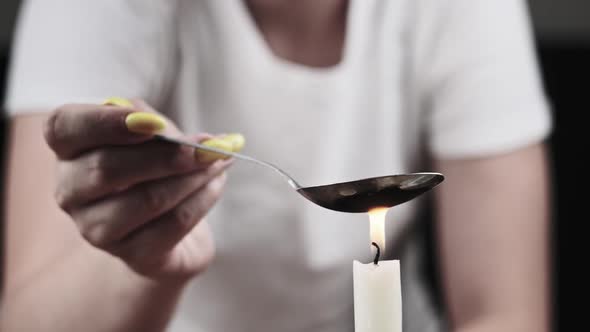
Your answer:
(6, 0), (550, 332)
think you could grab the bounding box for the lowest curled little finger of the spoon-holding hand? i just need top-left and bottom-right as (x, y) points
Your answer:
(110, 174), (225, 264)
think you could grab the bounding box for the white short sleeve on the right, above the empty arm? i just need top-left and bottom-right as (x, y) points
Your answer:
(418, 0), (551, 158)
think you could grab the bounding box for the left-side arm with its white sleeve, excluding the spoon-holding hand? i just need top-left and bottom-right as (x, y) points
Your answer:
(0, 0), (205, 331)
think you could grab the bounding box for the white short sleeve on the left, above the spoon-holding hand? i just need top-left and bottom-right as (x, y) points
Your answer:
(5, 0), (176, 115)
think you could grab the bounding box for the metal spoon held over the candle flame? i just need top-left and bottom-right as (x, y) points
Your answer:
(155, 135), (444, 213)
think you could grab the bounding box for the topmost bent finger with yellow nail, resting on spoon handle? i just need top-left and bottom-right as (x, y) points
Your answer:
(44, 105), (168, 159)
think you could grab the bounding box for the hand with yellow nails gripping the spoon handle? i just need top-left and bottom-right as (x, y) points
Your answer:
(45, 101), (236, 280)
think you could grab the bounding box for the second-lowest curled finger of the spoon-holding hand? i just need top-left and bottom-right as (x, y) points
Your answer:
(71, 162), (231, 248)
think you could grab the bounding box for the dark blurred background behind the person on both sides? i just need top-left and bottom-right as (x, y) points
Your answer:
(0, 0), (590, 331)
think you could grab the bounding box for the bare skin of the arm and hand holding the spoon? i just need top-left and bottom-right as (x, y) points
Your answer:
(0, 102), (231, 331)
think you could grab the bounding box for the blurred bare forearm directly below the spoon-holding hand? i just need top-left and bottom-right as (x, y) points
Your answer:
(0, 241), (182, 332)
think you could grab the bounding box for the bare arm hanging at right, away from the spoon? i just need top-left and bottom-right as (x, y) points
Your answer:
(437, 144), (550, 332)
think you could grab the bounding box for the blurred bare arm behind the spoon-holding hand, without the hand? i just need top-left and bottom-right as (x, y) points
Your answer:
(0, 115), (183, 331)
